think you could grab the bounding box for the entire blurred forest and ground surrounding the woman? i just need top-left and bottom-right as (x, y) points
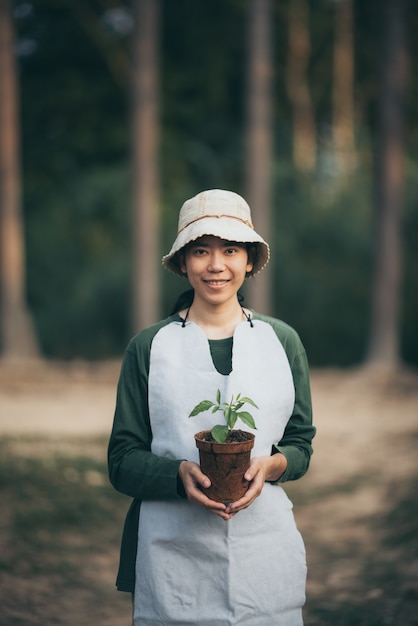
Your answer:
(0, 0), (418, 626)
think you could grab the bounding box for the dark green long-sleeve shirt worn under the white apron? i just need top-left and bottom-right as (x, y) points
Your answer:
(108, 313), (315, 591)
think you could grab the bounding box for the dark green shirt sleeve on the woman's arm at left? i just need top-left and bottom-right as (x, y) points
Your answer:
(108, 314), (185, 500)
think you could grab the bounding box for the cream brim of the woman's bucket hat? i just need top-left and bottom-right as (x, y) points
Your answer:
(162, 215), (270, 276)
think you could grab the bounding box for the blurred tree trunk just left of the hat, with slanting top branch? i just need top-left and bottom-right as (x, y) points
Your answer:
(40, 0), (160, 332)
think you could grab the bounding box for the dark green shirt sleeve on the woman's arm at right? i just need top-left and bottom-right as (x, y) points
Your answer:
(254, 314), (316, 483)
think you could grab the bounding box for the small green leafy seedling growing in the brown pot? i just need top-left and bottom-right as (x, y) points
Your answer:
(189, 389), (258, 443)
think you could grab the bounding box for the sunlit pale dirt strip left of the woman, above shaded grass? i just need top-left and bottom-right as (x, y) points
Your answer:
(0, 362), (119, 437)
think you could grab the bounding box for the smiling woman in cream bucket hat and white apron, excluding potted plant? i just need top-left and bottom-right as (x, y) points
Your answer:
(109, 189), (315, 626)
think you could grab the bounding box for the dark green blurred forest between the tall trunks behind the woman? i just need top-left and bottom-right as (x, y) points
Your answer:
(3, 0), (418, 366)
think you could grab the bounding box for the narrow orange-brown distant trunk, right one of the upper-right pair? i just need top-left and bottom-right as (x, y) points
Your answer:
(333, 0), (355, 176)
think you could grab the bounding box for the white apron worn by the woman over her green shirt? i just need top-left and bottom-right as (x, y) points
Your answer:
(134, 320), (306, 626)
